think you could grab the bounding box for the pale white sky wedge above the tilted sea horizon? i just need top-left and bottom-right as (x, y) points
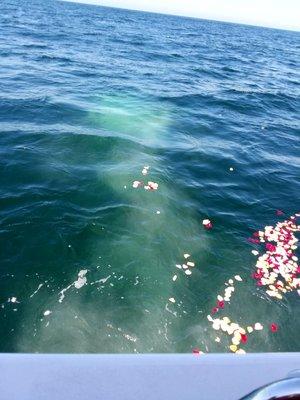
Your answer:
(65, 0), (300, 31)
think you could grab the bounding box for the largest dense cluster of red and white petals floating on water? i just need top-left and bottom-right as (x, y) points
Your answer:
(250, 214), (300, 299)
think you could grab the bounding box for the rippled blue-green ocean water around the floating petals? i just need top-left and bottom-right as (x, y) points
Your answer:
(0, 0), (300, 353)
